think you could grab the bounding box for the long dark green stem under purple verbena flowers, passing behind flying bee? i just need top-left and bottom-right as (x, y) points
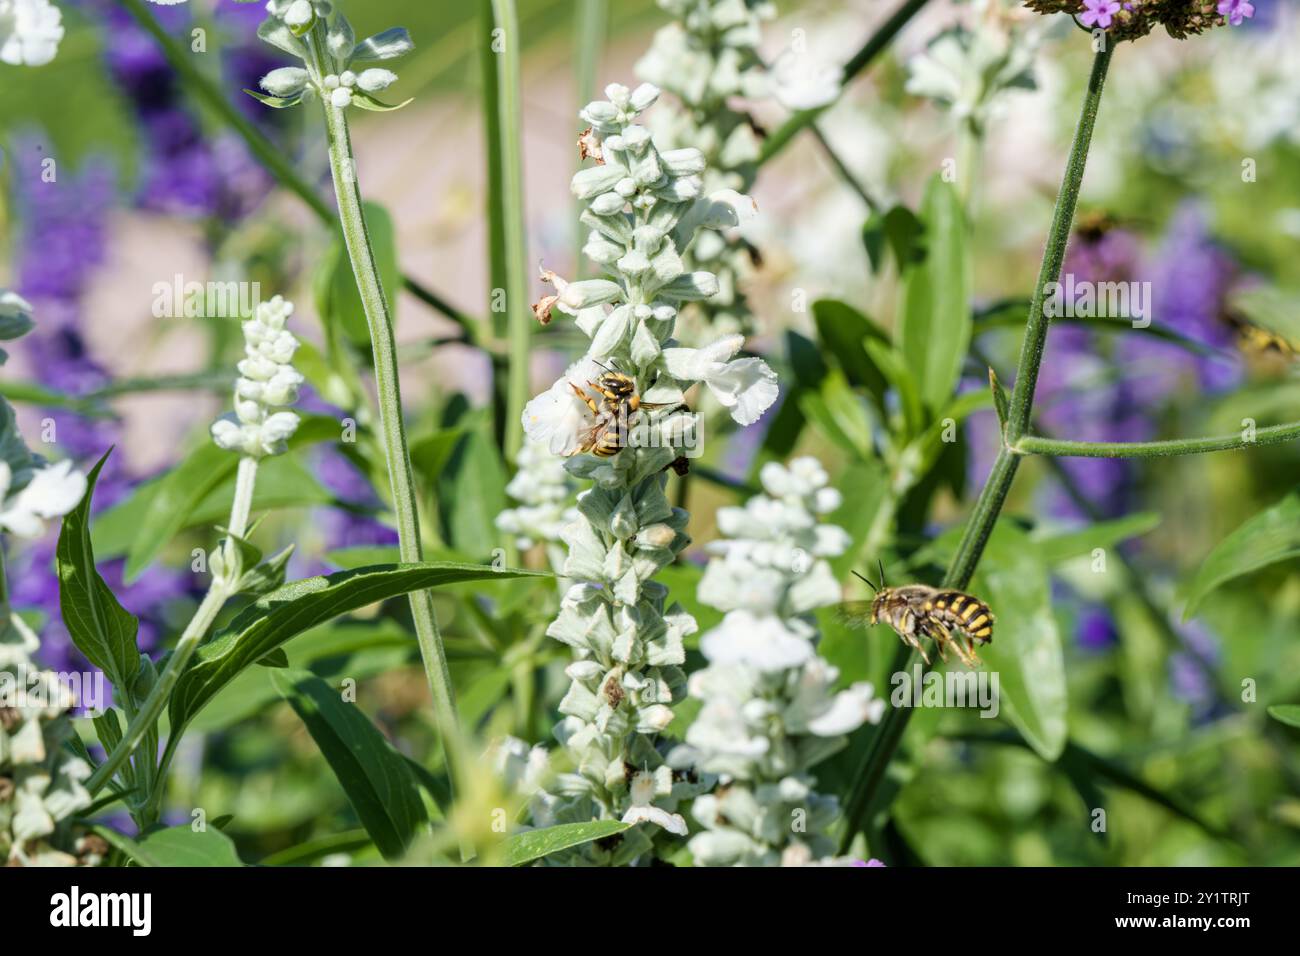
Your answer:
(841, 43), (1114, 852)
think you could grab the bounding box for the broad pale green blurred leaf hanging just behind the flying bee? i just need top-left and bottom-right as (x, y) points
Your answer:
(971, 522), (1067, 760)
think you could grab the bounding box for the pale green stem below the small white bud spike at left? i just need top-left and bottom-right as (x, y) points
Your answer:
(86, 457), (257, 790)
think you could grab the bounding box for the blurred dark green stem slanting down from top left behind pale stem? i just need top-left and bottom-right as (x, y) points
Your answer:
(122, 0), (475, 334)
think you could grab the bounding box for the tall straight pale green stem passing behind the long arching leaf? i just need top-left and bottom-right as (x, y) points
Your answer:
(307, 31), (456, 780)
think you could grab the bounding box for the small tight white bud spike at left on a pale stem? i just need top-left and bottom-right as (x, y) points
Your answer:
(212, 295), (303, 458)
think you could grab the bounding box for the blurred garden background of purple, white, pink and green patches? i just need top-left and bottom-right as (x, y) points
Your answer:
(0, 0), (1300, 865)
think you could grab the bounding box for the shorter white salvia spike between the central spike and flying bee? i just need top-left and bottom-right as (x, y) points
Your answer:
(670, 458), (884, 866)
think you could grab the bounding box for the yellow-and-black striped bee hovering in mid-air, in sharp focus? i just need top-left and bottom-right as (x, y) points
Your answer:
(840, 564), (993, 667)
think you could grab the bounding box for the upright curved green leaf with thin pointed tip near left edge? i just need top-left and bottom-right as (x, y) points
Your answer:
(55, 449), (140, 691)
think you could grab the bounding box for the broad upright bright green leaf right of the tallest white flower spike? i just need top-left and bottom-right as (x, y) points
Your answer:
(898, 176), (972, 410)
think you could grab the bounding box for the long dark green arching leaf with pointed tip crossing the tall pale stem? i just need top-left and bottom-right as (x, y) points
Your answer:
(169, 562), (543, 734)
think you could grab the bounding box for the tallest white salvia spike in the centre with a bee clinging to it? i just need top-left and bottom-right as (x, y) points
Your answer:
(517, 83), (776, 864)
